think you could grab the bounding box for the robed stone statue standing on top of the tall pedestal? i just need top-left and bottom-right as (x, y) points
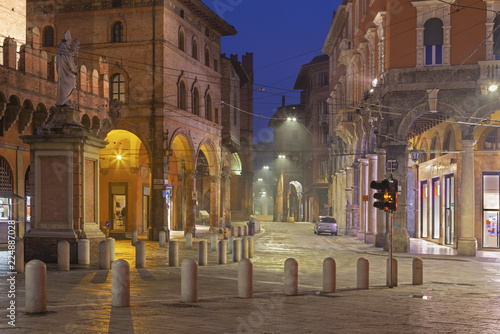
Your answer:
(56, 30), (80, 107)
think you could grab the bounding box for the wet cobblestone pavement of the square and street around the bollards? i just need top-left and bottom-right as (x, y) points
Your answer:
(0, 223), (500, 333)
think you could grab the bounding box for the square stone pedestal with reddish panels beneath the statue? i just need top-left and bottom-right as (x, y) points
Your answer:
(21, 107), (105, 263)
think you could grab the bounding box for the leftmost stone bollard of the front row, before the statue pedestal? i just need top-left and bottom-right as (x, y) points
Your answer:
(24, 260), (47, 313)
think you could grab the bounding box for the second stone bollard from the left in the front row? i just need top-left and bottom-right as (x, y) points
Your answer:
(111, 260), (131, 307)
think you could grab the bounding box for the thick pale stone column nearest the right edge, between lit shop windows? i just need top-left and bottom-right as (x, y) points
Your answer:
(458, 140), (477, 256)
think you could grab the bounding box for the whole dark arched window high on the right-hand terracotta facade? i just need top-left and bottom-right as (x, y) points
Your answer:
(424, 18), (443, 65)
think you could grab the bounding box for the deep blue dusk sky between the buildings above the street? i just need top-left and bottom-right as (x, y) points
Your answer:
(204, 0), (341, 143)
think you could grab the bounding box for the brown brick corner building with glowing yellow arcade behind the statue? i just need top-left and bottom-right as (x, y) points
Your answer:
(27, 0), (253, 243)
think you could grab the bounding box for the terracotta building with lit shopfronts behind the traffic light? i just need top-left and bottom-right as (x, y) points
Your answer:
(323, 0), (500, 256)
